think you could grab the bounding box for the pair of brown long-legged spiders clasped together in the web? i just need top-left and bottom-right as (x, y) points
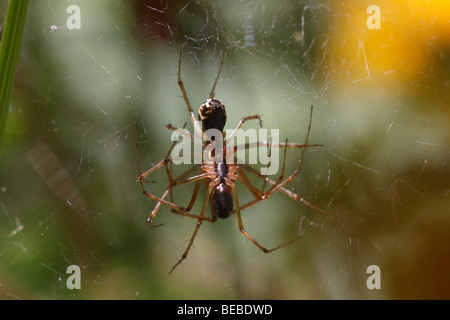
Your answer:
(136, 51), (328, 273)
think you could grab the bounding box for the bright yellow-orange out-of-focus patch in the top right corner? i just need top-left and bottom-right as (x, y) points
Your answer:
(329, 0), (450, 94)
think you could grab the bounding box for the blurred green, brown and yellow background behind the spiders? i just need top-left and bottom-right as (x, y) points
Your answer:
(0, 0), (450, 299)
